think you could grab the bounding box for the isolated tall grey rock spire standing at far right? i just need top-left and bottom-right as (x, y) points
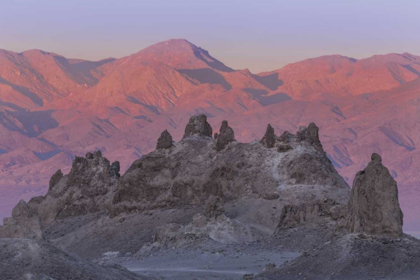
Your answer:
(348, 153), (404, 237)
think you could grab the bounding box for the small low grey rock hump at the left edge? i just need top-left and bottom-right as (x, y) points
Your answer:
(0, 200), (44, 240)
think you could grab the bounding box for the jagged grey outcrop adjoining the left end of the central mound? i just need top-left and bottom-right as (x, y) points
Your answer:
(28, 151), (120, 225)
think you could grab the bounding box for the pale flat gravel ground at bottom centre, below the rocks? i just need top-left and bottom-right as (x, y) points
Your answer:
(101, 240), (300, 280)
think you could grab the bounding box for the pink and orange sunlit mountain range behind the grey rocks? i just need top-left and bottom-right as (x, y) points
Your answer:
(0, 39), (420, 230)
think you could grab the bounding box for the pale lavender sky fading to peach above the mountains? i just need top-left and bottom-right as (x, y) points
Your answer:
(0, 0), (420, 73)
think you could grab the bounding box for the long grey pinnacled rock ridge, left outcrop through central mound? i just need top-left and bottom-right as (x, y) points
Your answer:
(4, 115), (348, 229)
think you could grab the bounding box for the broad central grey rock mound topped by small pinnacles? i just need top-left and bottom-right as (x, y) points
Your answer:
(110, 117), (349, 215)
